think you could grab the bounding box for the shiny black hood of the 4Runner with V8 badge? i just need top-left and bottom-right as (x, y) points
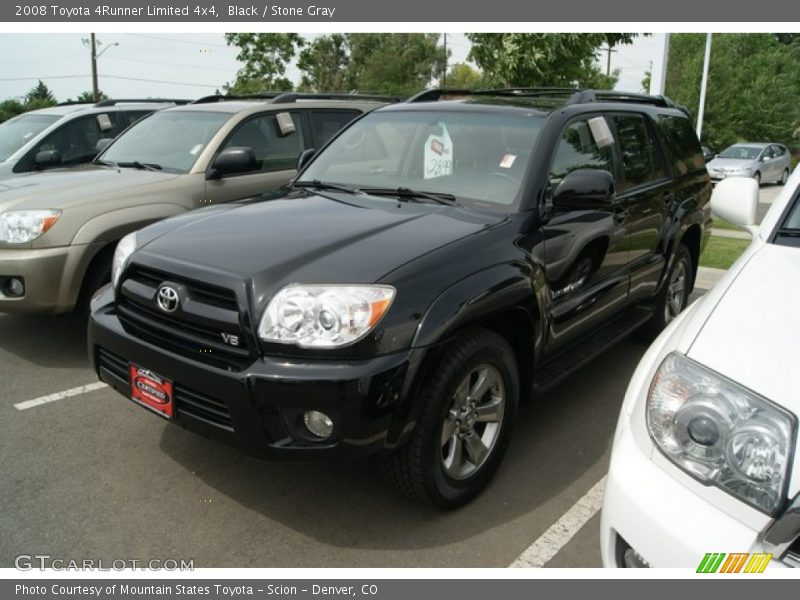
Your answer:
(133, 193), (504, 297)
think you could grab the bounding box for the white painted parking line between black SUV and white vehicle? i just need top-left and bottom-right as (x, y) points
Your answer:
(511, 476), (606, 568)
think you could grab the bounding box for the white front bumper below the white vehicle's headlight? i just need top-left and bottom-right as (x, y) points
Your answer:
(600, 425), (785, 570)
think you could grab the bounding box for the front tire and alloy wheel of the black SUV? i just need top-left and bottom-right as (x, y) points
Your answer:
(384, 329), (519, 509)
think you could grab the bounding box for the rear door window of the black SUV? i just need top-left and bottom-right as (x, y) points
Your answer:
(614, 115), (666, 188)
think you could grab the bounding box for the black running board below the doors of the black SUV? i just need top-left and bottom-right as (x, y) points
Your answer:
(533, 306), (653, 396)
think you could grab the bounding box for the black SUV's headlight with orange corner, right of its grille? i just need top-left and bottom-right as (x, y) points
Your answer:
(258, 285), (395, 348)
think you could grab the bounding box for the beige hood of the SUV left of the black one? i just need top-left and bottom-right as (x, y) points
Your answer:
(0, 165), (180, 212)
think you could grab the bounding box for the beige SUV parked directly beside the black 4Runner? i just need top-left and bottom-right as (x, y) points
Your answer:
(0, 94), (394, 313)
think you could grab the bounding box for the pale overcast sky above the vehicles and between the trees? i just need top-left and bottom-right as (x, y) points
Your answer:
(0, 32), (658, 101)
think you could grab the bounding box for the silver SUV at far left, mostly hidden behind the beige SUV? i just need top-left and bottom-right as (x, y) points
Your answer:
(0, 99), (189, 178)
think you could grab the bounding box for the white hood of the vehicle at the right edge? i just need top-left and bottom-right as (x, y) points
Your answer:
(688, 244), (800, 415)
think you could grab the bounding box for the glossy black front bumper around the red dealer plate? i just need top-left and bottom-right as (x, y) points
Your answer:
(88, 296), (418, 460)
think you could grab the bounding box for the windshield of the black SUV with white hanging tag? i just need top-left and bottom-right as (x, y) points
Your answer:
(298, 110), (544, 211)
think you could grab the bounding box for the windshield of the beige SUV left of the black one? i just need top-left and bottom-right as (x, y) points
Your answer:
(97, 110), (231, 173)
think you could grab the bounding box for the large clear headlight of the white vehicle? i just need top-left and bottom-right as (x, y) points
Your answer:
(647, 353), (795, 514)
